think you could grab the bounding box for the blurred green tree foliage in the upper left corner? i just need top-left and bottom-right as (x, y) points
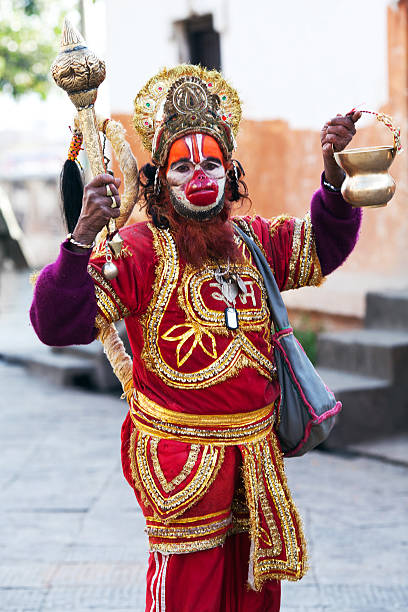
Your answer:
(0, 0), (72, 98)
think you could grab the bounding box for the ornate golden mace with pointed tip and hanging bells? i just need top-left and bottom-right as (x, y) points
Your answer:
(51, 18), (122, 279)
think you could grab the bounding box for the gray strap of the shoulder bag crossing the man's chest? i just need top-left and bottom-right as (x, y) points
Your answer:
(233, 223), (290, 331)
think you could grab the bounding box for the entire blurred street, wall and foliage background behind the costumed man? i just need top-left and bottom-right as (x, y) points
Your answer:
(0, 0), (408, 612)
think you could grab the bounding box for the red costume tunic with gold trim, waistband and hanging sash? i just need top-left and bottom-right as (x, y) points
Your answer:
(89, 215), (322, 589)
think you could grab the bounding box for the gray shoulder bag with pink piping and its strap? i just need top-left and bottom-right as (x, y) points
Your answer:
(234, 224), (342, 457)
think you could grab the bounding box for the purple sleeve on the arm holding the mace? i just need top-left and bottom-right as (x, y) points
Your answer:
(30, 243), (97, 346)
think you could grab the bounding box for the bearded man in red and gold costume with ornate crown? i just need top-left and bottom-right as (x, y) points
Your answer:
(31, 65), (361, 612)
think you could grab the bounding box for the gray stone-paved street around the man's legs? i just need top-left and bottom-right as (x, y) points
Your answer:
(0, 274), (408, 612)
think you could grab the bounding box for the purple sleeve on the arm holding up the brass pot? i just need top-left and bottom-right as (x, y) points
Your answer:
(310, 176), (362, 276)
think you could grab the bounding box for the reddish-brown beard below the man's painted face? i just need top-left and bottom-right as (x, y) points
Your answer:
(165, 200), (241, 268)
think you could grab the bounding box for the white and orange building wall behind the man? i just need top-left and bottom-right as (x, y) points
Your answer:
(104, 0), (408, 317)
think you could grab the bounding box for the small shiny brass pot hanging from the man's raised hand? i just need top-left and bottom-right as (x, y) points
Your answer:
(334, 146), (396, 208)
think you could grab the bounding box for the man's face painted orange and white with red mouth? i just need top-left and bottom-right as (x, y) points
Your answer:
(166, 134), (230, 220)
